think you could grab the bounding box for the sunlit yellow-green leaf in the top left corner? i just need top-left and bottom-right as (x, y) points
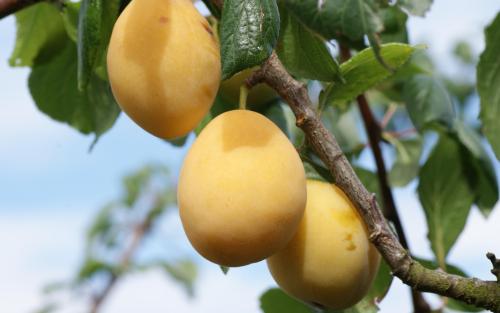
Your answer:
(9, 3), (65, 66)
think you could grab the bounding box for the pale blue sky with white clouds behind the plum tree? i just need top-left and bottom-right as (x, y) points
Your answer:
(0, 0), (500, 313)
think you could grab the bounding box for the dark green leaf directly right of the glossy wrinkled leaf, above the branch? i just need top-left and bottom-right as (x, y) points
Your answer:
(276, 9), (340, 81)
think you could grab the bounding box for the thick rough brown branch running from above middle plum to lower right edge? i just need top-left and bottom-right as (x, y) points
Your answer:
(247, 53), (500, 312)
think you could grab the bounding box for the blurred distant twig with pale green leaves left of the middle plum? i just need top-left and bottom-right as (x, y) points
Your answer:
(38, 164), (197, 313)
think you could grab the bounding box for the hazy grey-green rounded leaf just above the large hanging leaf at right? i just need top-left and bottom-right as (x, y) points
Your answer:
(403, 74), (455, 132)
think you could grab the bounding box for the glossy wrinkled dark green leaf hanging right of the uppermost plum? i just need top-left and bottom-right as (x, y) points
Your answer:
(220, 0), (280, 79)
